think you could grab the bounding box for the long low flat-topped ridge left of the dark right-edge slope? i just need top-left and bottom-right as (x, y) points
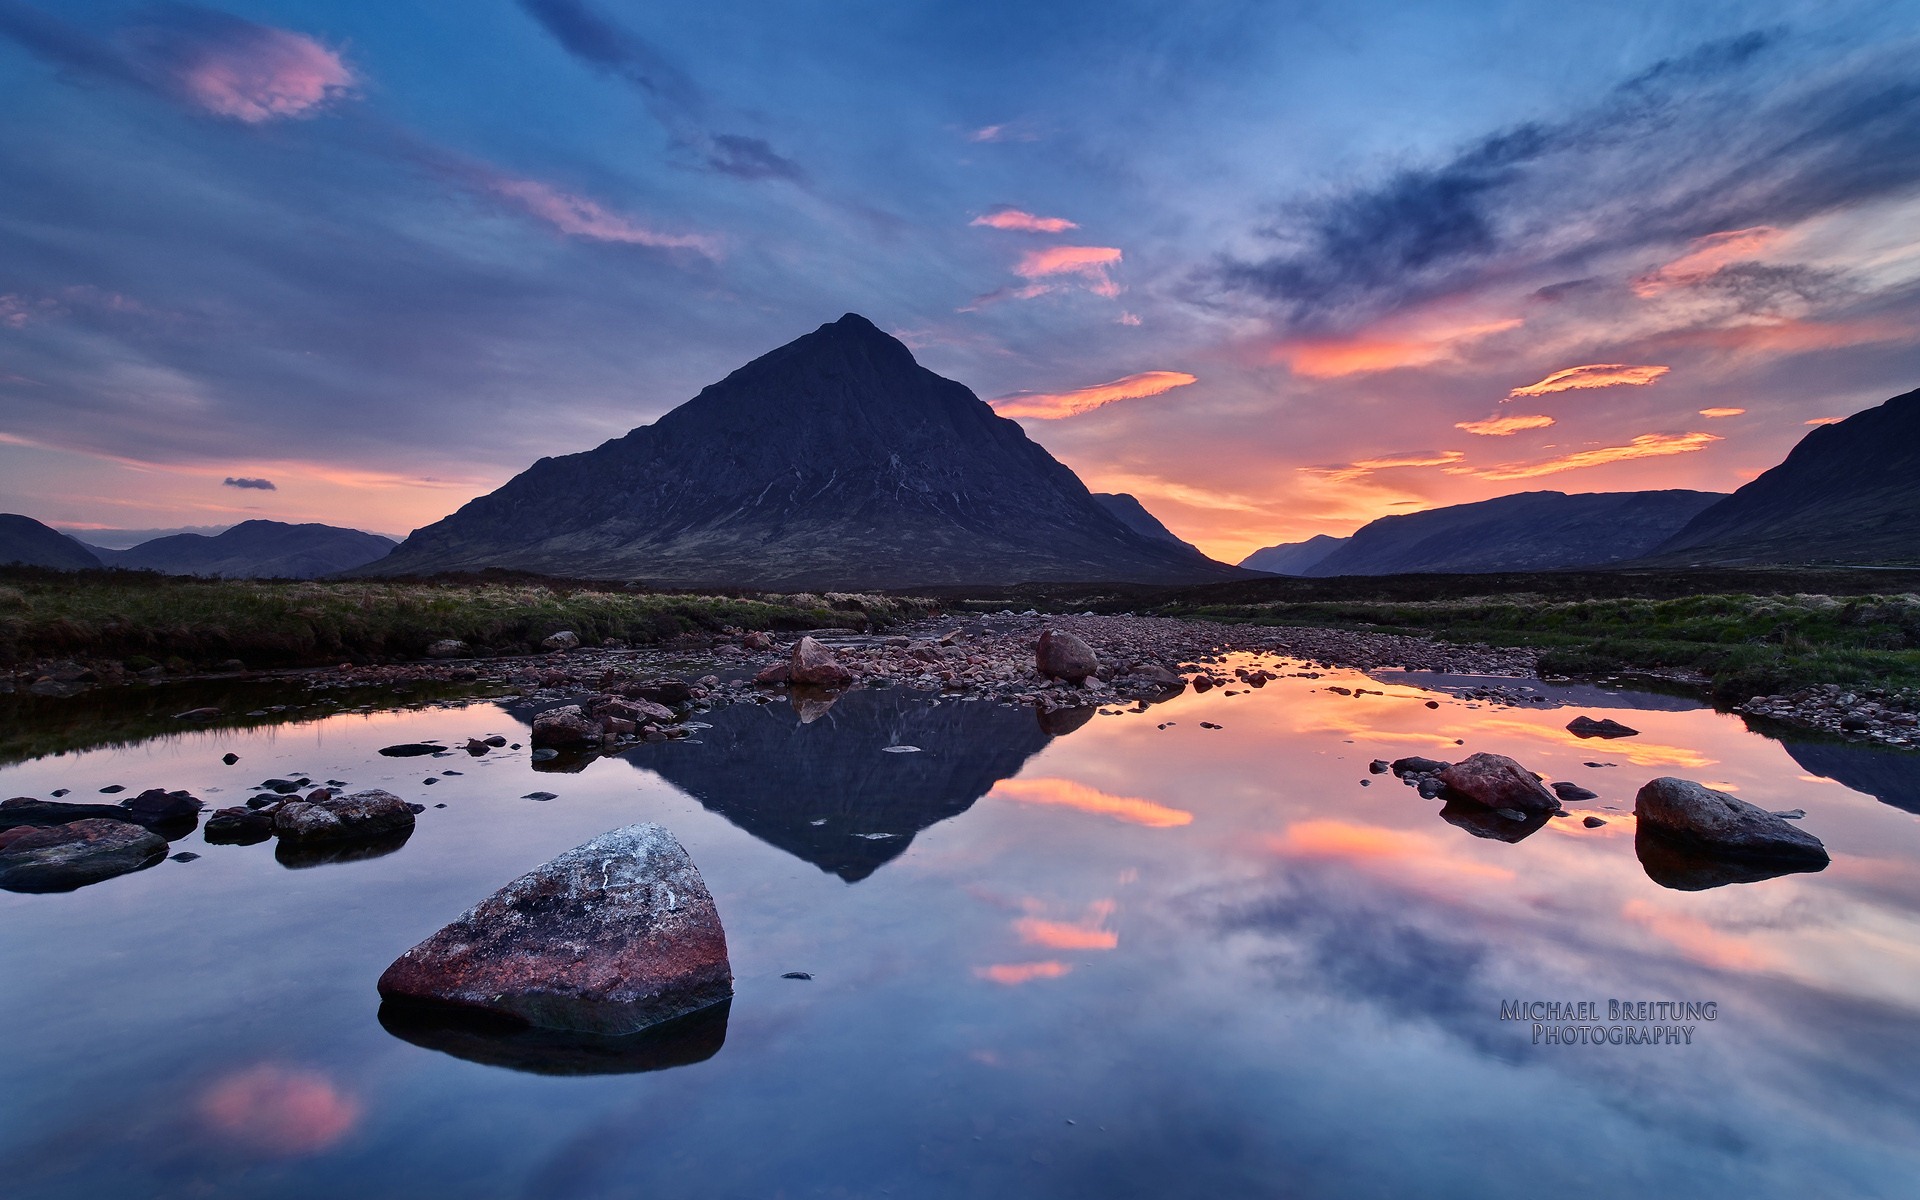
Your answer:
(1304, 492), (1724, 578)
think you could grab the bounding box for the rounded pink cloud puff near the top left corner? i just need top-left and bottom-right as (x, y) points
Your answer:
(173, 21), (357, 125)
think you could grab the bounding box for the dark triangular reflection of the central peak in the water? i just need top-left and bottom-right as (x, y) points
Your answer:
(620, 687), (1059, 883)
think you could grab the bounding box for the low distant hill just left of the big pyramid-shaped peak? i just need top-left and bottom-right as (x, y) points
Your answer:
(98, 520), (394, 580)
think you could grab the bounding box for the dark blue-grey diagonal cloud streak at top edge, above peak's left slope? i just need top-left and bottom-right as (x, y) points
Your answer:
(518, 0), (808, 184)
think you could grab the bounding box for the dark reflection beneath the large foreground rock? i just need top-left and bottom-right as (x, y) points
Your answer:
(380, 1000), (732, 1075)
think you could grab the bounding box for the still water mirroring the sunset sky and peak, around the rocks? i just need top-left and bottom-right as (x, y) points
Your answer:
(0, 659), (1920, 1198)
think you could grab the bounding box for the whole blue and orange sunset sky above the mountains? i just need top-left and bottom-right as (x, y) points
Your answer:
(0, 0), (1920, 561)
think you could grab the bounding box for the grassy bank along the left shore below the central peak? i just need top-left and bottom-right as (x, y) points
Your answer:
(0, 568), (925, 670)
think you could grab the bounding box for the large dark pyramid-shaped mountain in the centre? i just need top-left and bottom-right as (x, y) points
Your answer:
(359, 313), (1240, 589)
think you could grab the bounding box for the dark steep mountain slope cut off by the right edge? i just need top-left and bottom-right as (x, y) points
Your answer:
(1655, 392), (1920, 566)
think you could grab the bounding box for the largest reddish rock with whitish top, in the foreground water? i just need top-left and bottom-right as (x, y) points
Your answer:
(380, 826), (733, 1033)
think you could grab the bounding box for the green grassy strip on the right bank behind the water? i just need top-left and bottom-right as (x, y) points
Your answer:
(1160, 593), (1920, 701)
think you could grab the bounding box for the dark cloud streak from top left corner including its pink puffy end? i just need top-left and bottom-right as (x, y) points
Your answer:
(0, 2), (359, 125)
